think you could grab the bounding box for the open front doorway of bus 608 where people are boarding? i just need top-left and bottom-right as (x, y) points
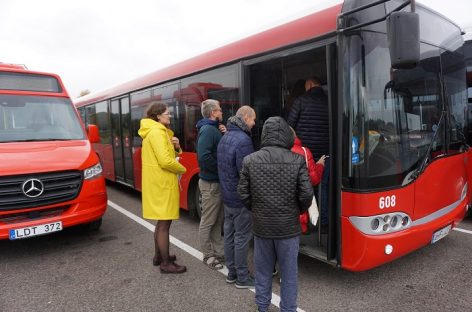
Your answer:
(243, 42), (339, 264)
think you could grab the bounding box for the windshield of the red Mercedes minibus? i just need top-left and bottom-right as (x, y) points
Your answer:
(0, 94), (85, 143)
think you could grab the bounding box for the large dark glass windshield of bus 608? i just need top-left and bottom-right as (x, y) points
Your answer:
(343, 4), (466, 190)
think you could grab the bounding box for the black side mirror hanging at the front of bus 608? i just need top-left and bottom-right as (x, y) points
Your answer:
(387, 12), (420, 69)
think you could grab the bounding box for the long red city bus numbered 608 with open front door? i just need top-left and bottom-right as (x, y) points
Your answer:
(75, 0), (469, 271)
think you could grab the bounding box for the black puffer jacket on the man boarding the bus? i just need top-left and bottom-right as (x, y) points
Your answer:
(287, 87), (329, 161)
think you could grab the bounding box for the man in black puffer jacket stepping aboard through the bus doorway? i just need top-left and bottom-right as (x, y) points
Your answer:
(287, 77), (330, 233)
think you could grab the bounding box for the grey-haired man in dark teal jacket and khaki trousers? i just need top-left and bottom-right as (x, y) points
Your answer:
(197, 99), (226, 270)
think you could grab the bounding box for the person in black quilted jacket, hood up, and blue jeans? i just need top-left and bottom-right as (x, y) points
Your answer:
(238, 117), (313, 311)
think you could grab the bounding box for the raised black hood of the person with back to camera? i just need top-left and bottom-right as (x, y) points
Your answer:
(261, 116), (295, 149)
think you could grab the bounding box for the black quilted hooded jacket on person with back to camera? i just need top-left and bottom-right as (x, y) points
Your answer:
(238, 117), (313, 239)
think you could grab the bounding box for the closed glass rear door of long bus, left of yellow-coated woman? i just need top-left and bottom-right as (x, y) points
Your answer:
(111, 97), (134, 186)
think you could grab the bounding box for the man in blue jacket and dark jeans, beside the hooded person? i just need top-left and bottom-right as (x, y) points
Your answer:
(217, 106), (256, 288)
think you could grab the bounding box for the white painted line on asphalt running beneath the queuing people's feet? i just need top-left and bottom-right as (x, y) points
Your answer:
(108, 200), (305, 312)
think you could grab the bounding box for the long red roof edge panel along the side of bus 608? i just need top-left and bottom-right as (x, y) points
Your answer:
(74, 4), (342, 107)
